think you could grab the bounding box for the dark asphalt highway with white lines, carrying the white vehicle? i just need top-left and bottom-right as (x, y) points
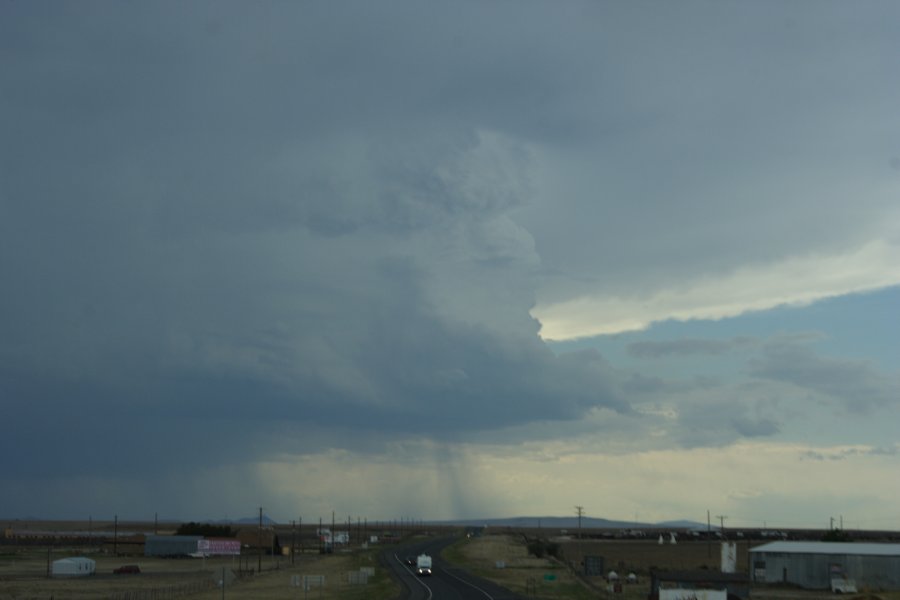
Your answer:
(382, 537), (525, 600)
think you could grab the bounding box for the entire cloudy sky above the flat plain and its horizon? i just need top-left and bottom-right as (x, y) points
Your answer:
(0, 0), (900, 530)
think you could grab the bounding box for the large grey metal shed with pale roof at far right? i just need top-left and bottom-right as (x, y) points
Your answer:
(750, 542), (900, 590)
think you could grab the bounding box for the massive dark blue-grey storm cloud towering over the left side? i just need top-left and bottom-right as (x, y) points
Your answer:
(0, 4), (629, 477)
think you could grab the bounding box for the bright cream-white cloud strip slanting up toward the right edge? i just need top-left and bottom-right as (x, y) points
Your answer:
(532, 240), (900, 341)
